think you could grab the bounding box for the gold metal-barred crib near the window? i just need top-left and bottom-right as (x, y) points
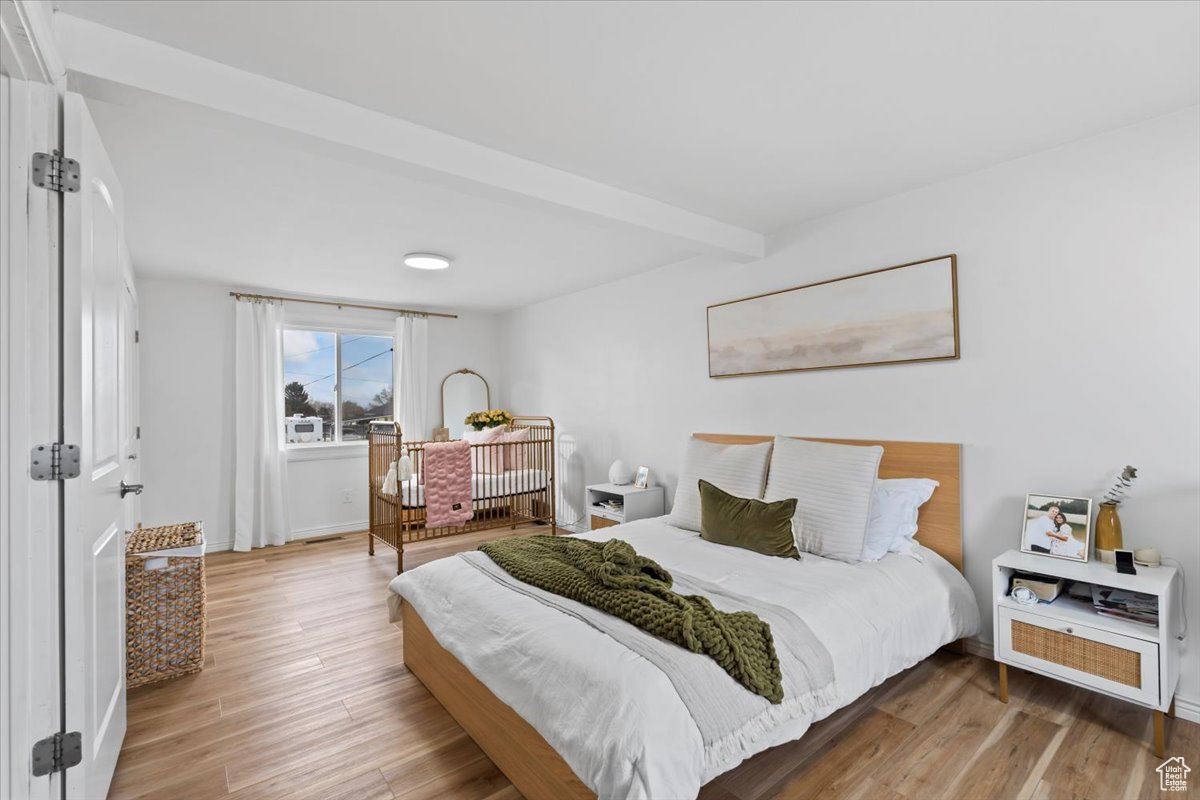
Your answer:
(367, 416), (558, 575)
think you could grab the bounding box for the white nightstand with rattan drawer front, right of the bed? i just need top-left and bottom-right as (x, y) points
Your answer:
(991, 551), (1182, 758)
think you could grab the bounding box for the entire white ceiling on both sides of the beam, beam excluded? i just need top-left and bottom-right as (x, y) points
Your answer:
(56, 0), (1200, 311)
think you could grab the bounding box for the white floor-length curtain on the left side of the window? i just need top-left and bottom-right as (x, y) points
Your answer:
(233, 300), (292, 551)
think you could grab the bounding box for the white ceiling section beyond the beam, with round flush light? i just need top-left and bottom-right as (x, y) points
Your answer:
(88, 100), (688, 311)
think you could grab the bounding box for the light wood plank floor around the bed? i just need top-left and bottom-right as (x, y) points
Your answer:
(110, 531), (1200, 800)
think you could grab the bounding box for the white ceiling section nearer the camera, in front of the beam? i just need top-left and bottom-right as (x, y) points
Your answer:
(58, 0), (1200, 231)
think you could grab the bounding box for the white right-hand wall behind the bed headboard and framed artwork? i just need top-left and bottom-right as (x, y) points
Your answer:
(506, 108), (1200, 716)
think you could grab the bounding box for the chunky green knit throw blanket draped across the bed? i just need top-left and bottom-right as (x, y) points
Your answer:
(479, 536), (784, 703)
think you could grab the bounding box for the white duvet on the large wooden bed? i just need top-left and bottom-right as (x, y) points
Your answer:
(389, 517), (979, 800)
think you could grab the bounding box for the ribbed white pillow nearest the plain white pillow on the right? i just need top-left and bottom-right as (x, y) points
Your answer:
(763, 437), (883, 564)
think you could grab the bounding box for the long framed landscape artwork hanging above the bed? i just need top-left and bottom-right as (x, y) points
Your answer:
(708, 254), (959, 378)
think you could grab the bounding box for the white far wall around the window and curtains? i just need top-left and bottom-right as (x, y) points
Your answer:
(137, 278), (503, 549)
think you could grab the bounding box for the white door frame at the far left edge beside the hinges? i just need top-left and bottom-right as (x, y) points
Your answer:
(0, 71), (62, 800)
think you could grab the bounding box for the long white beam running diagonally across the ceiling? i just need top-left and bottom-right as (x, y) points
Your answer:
(54, 13), (766, 261)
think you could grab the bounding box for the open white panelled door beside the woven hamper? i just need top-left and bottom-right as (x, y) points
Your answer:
(62, 92), (133, 799)
